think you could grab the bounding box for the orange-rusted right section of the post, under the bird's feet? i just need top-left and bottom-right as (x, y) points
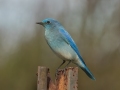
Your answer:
(56, 67), (78, 90)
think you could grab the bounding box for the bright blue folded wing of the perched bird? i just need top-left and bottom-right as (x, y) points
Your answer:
(59, 28), (85, 64)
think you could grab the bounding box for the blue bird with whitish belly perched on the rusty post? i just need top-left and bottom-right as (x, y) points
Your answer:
(37, 18), (95, 80)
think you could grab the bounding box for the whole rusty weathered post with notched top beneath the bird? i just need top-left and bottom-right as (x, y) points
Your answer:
(37, 66), (78, 90)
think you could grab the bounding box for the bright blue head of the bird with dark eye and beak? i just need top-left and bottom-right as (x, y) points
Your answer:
(36, 18), (61, 29)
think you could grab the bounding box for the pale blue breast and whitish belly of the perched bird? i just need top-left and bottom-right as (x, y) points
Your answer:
(45, 33), (77, 60)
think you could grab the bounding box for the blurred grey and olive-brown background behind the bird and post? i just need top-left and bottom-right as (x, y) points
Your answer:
(0, 0), (120, 90)
